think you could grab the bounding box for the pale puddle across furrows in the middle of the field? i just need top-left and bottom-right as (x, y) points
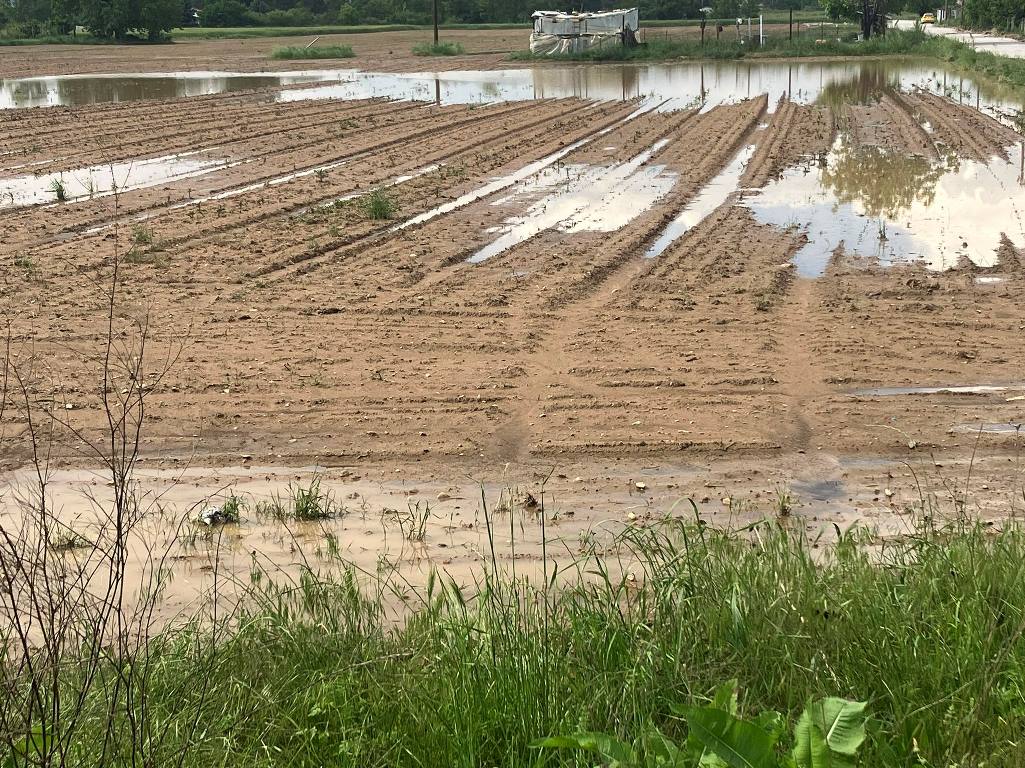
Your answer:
(467, 139), (677, 264)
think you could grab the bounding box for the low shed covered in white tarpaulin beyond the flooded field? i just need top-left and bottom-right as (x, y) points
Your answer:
(530, 8), (638, 55)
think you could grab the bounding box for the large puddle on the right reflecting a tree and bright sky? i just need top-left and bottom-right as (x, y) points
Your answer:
(743, 143), (1025, 276)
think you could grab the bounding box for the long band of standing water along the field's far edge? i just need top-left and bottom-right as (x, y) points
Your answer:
(8, 60), (1025, 116)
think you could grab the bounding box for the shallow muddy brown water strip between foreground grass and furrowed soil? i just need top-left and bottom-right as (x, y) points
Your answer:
(0, 456), (993, 620)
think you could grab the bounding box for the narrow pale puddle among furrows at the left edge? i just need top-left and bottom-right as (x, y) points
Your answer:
(0, 151), (231, 208)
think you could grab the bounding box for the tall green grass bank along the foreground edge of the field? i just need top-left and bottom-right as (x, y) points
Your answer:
(8, 500), (1025, 768)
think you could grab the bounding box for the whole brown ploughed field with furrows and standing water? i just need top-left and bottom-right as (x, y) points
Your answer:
(0, 53), (1025, 611)
